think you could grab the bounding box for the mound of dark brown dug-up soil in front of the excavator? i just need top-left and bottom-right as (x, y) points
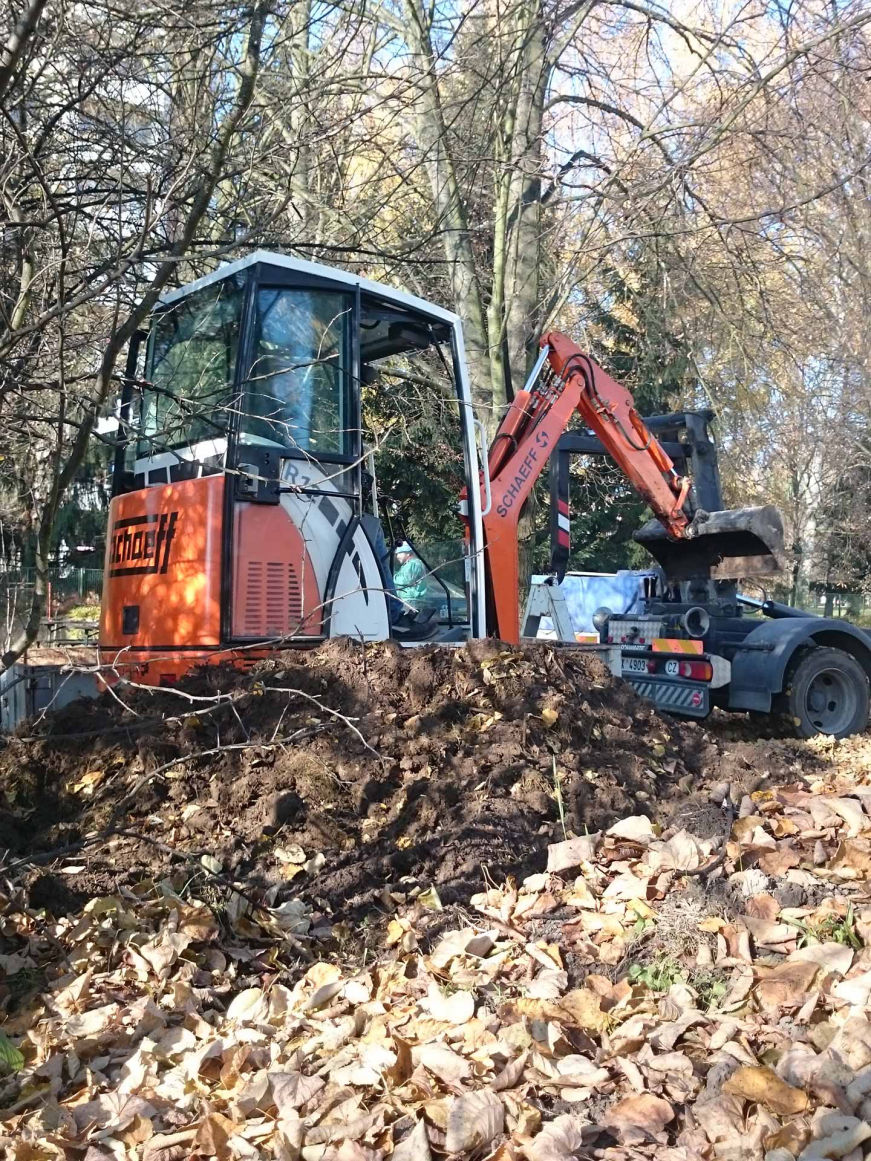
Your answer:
(0, 641), (807, 916)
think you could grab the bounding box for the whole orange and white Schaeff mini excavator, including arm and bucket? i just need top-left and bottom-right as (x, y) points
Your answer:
(100, 252), (783, 684)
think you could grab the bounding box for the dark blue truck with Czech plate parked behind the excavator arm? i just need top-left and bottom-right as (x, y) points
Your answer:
(550, 409), (871, 737)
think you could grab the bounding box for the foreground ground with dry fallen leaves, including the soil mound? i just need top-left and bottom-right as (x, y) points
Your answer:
(0, 649), (871, 1161)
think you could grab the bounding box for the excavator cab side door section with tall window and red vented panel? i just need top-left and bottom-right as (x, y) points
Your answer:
(226, 270), (389, 642)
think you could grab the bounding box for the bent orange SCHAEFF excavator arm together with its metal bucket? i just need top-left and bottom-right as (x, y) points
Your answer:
(473, 332), (783, 642)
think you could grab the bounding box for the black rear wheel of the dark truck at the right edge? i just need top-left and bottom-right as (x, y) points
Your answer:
(782, 646), (869, 737)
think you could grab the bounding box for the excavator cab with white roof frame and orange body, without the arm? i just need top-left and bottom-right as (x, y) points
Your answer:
(100, 252), (485, 684)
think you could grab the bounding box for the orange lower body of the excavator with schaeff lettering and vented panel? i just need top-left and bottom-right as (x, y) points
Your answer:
(100, 475), (322, 685)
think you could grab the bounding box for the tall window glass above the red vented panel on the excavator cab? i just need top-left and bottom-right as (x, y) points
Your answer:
(239, 287), (352, 459)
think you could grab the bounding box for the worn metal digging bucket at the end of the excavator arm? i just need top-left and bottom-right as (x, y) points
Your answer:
(634, 504), (784, 581)
